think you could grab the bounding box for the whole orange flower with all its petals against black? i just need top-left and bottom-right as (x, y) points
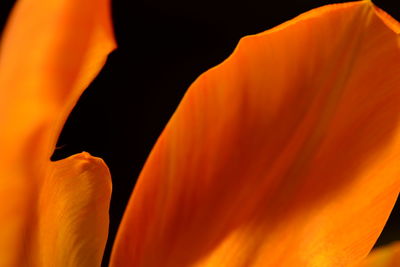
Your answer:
(0, 0), (400, 267)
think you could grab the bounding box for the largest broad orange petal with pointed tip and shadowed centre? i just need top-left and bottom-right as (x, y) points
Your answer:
(111, 1), (400, 267)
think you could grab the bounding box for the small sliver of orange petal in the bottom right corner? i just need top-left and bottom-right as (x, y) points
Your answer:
(358, 242), (400, 267)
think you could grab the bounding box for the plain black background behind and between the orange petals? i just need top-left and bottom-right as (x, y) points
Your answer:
(0, 0), (400, 266)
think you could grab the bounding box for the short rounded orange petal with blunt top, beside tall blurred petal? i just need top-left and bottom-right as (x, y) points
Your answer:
(38, 153), (111, 267)
